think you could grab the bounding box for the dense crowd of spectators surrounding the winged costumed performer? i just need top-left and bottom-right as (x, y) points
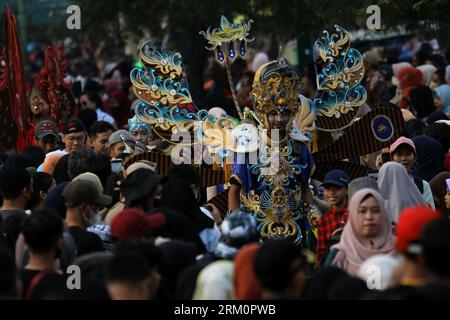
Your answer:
(0, 38), (450, 300)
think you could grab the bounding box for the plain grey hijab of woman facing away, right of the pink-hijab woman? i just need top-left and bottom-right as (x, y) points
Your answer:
(378, 161), (427, 223)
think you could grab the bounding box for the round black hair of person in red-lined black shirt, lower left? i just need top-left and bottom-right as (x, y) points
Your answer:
(22, 209), (64, 253)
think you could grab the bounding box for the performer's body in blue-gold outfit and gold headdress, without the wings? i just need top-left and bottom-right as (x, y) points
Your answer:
(228, 58), (314, 246)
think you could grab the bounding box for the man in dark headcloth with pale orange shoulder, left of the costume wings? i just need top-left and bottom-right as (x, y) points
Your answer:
(42, 118), (87, 174)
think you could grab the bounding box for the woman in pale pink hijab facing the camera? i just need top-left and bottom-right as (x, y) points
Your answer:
(327, 189), (396, 276)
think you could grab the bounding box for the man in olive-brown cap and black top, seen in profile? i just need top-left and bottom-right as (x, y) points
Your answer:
(63, 179), (112, 256)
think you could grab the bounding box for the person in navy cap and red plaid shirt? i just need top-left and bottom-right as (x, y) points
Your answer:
(316, 170), (350, 266)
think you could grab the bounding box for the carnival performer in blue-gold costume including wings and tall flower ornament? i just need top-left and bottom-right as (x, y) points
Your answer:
(124, 17), (403, 249)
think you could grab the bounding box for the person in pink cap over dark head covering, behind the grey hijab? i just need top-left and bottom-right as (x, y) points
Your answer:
(389, 137), (435, 209)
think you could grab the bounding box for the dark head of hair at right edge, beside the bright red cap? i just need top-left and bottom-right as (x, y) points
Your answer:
(421, 219), (450, 279)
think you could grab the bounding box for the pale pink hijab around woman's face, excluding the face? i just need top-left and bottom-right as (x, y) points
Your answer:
(332, 188), (395, 276)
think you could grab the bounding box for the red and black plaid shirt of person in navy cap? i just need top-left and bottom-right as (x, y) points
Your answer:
(316, 207), (348, 266)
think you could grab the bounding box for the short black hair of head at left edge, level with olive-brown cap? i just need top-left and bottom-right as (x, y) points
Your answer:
(0, 166), (31, 200)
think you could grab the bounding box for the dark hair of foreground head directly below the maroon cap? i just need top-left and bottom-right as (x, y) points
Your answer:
(106, 253), (150, 284)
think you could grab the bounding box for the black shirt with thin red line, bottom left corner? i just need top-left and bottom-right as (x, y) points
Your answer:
(20, 269), (68, 300)
